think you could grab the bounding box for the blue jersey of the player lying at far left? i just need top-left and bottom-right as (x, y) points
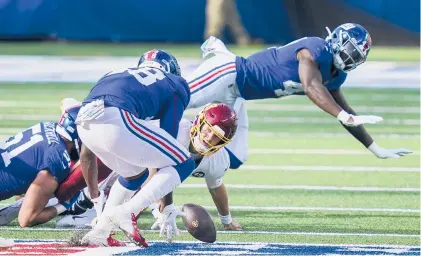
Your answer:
(0, 121), (70, 200)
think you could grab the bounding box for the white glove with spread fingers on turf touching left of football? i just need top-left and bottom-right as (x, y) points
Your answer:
(151, 204), (186, 243)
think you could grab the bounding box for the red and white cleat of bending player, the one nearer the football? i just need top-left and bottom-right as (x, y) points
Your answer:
(110, 211), (148, 247)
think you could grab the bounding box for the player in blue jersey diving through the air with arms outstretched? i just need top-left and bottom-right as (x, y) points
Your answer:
(187, 23), (412, 168)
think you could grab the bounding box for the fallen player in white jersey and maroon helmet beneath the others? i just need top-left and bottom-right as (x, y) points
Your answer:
(56, 103), (241, 234)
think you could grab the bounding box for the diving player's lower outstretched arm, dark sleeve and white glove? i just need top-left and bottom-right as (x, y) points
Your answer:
(329, 88), (412, 158)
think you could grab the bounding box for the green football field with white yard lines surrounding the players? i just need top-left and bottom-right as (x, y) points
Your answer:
(0, 43), (420, 255)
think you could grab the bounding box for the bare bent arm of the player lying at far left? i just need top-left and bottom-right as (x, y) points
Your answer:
(18, 170), (58, 228)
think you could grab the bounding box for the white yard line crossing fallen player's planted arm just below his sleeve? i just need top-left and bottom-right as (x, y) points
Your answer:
(180, 184), (421, 192)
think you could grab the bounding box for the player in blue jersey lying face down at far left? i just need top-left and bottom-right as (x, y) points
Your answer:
(0, 101), (80, 227)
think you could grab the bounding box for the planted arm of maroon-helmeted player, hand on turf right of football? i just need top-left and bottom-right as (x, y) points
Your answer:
(206, 179), (242, 230)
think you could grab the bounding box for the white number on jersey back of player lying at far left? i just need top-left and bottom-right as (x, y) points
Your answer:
(0, 124), (44, 167)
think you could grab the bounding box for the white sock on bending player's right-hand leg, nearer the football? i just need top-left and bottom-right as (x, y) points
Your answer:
(122, 167), (181, 215)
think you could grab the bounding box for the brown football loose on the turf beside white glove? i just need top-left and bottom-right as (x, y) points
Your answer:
(182, 203), (216, 243)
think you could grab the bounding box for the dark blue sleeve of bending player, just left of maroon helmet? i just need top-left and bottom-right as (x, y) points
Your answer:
(159, 94), (185, 139)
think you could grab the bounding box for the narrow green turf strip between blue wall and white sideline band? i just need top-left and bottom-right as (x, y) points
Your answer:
(0, 42), (420, 62)
